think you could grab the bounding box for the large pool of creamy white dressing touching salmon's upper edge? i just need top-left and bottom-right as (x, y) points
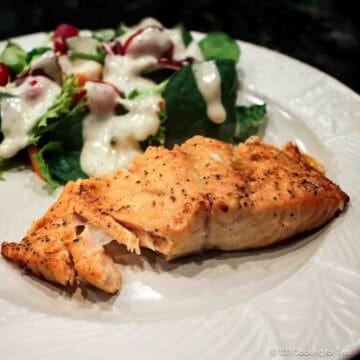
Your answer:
(80, 83), (161, 176)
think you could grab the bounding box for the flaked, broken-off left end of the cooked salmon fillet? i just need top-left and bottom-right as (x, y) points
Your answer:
(1, 182), (125, 293)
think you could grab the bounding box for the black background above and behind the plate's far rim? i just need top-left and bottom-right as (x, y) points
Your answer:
(0, 0), (360, 92)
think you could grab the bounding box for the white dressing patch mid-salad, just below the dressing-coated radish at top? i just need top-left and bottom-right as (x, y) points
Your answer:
(103, 55), (157, 95)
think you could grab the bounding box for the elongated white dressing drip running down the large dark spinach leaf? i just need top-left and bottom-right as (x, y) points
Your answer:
(192, 61), (226, 124)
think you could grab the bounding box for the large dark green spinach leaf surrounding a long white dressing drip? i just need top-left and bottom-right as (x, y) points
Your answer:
(164, 60), (238, 146)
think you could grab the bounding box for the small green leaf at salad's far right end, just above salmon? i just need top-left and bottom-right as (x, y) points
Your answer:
(234, 104), (266, 142)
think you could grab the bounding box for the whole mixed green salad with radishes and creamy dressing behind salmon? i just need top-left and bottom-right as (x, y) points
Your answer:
(0, 18), (266, 188)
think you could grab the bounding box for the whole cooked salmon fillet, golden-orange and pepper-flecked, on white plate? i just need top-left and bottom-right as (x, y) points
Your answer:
(2, 136), (349, 293)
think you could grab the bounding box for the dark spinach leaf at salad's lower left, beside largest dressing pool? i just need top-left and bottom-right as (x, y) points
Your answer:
(36, 141), (87, 188)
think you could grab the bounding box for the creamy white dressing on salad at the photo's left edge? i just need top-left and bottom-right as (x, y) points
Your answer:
(0, 76), (61, 158)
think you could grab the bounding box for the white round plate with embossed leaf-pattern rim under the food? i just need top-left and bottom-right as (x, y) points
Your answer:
(0, 34), (360, 360)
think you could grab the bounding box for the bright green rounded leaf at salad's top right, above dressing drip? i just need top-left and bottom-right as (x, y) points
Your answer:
(199, 32), (240, 61)
